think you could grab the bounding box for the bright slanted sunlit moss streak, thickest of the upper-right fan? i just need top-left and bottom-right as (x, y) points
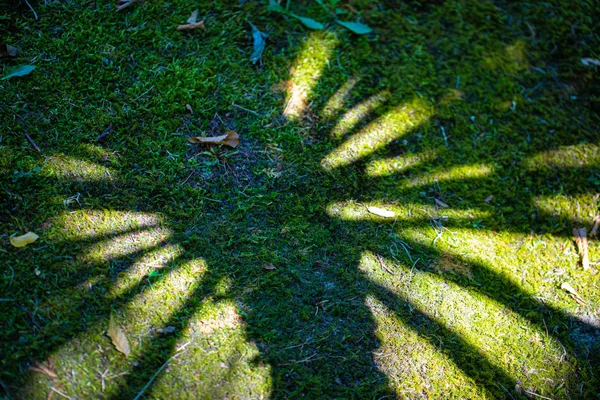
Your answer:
(321, 99), (432, 170)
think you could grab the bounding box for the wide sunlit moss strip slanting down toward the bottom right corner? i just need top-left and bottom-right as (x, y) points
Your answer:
(361, 253), (575, 397)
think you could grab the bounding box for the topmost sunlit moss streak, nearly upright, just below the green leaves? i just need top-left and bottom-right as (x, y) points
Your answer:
(283, 32), (337, 119)
